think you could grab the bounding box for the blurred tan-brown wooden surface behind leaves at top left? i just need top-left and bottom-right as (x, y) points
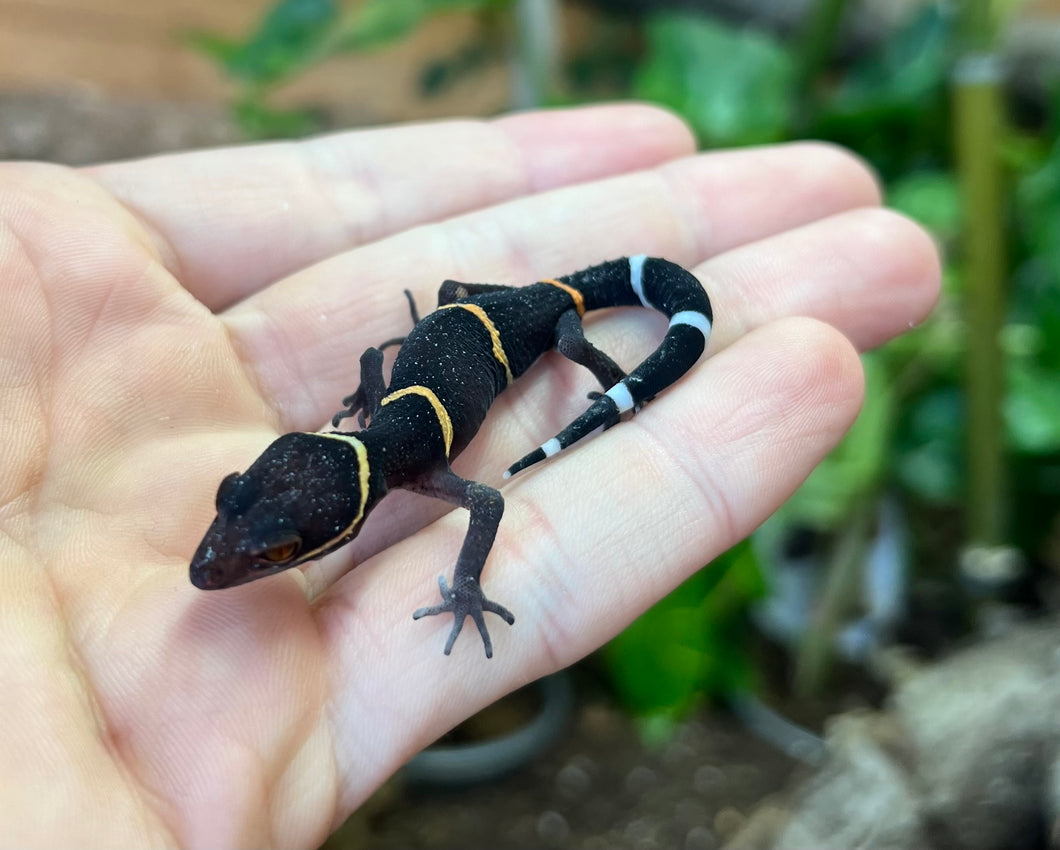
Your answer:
(0, 0), (508, 123)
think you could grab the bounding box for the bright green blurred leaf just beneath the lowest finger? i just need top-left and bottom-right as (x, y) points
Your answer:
(603, 541), (765, 716)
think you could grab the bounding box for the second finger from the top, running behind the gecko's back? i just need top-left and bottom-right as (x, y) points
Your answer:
(226, 144), (878, 428)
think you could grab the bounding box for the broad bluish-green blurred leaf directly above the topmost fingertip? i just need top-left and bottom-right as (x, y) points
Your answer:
(634, 13), (796, 146)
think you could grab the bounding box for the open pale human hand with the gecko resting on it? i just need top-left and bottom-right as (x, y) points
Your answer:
(0, 105), (939, 847)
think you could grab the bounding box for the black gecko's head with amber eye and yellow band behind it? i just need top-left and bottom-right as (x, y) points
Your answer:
(191, 432), (371, 590)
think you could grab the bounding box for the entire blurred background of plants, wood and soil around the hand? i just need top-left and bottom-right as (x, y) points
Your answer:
(6, 0), (1060, 850)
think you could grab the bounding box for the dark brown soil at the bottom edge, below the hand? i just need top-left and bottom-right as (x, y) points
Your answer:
(334, 693), (795, 850)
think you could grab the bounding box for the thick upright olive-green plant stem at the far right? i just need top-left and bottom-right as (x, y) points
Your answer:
(953, 0), (1007, 546)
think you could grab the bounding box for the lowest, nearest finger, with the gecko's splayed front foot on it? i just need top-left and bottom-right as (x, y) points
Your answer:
(318, 319), (863, 810)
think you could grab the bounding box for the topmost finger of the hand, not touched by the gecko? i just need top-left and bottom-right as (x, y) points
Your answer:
(82, 104), (694, 309)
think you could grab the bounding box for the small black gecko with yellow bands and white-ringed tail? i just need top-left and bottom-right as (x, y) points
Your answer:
(191, 254), (713, 657)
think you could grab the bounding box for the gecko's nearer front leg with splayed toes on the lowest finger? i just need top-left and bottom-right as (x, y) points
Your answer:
(406, 467), (515, 658)
